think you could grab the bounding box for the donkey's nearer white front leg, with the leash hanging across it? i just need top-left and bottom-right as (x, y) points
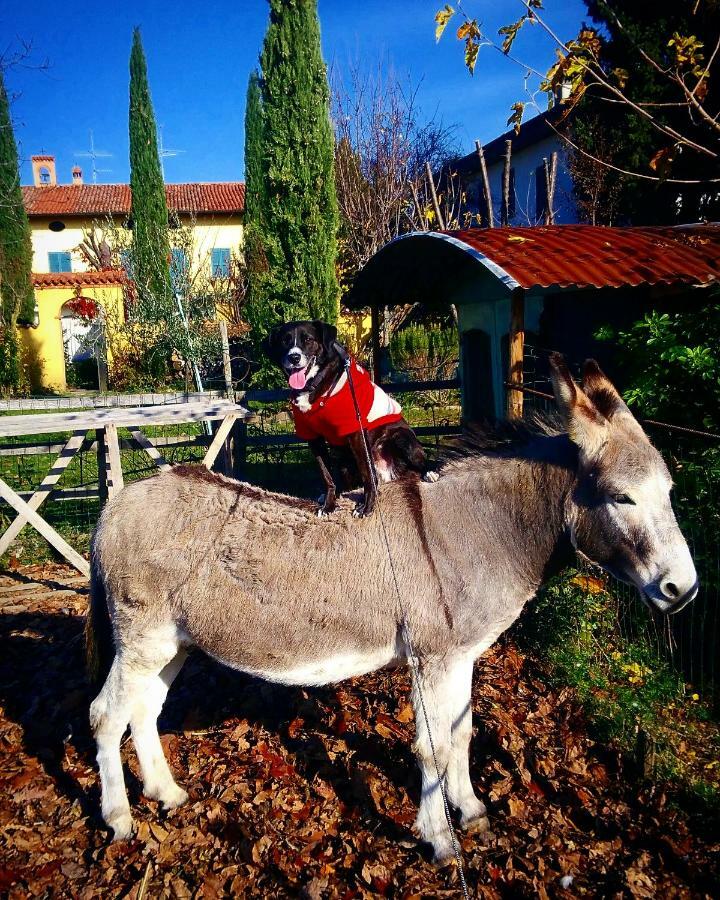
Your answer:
(411, 660), (456, 865)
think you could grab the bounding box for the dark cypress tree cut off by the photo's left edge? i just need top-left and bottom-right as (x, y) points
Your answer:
(0, 63), (35, 388)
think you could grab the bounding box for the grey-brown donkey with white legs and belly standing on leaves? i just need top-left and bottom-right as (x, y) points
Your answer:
(87, 356), (698, 863)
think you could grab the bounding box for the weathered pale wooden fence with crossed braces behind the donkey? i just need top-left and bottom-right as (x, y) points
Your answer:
(0, 380), (460, 573)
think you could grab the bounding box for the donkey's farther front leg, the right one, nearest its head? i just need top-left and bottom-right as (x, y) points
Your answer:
(447, 657), (489, 832)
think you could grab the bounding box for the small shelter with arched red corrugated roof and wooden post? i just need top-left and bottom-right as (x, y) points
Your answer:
(346, 225), (720, 420)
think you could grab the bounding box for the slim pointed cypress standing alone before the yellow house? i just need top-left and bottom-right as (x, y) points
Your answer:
(129, 28), (172, 310)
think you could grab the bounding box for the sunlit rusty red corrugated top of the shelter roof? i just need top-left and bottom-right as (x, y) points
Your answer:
(444, 225), (720, 288)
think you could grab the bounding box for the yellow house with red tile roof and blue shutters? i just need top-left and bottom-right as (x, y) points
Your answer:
(21, 155), (245, 391)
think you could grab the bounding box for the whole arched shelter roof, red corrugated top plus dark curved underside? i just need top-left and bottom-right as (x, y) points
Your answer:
(343, 224), (720, 309)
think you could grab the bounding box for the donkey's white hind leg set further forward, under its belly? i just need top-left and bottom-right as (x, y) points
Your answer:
(130, 649), (188, 810)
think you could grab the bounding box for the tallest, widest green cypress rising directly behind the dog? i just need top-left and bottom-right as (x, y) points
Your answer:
(246, 0), (339, 352)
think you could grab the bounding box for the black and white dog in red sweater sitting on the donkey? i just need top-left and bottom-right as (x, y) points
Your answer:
(268, 321), (437, 516)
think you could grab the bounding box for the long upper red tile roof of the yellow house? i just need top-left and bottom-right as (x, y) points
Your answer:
(22, 181), (245, 216)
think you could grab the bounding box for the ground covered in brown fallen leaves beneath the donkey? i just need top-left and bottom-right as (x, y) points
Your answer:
(0, 565), (720, 900)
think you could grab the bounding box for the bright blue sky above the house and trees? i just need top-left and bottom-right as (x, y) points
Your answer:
(0, 0), (585, 183)
